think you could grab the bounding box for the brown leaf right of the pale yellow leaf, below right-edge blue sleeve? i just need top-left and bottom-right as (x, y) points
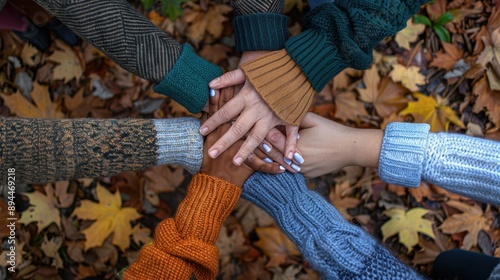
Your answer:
(439, 200), (491, 250)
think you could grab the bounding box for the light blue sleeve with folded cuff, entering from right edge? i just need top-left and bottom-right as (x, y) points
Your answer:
(378, 123), (500, 205)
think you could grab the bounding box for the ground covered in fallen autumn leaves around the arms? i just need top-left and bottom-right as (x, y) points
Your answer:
(0, 0), (500, 279)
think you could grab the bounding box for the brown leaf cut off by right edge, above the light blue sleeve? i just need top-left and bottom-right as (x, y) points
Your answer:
(472, 77), (500, 127)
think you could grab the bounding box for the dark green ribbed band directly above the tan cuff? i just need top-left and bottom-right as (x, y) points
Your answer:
(285, 30), (352, 92)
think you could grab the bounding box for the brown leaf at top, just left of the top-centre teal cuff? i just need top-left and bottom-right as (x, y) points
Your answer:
(183, 2), (233, 47)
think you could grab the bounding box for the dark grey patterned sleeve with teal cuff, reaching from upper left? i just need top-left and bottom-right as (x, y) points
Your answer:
(30, 0), (222, 113)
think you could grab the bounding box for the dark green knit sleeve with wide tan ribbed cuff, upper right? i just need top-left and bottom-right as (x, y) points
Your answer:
(242, 0), (428, 125)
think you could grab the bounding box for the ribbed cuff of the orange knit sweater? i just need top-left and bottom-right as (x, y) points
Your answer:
(175, 174), (241, 244)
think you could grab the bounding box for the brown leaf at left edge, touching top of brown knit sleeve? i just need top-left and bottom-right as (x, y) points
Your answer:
(1, 82), (64, 118)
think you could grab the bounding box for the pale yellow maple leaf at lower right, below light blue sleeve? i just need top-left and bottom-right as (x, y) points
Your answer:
(380, 207), (436, 251)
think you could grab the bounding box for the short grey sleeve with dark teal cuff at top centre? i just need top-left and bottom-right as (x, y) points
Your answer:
(231, 0), (289, 52)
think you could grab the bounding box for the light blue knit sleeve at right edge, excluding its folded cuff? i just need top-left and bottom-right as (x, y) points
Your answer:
(422, 133), (500, 205)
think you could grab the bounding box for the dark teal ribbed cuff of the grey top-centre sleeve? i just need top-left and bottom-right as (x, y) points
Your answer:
(233, 13), (288, 53)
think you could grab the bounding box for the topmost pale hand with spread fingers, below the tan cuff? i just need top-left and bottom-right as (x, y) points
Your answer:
(200, 69), (298, 165)
